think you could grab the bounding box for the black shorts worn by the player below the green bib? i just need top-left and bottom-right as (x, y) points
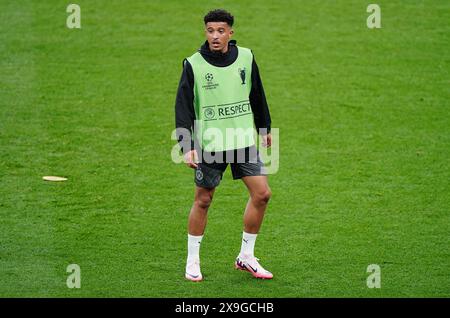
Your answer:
(194, 149), (266, 189)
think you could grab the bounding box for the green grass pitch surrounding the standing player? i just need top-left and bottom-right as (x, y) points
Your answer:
(0, 0), (450, 297)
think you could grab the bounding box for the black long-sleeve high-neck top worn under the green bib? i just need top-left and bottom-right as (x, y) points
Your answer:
(175, 40), (271, 153)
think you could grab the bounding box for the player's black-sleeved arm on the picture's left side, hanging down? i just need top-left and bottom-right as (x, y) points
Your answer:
(175, 59), (195, 154)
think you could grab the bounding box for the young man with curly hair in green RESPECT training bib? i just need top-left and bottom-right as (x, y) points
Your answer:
(175, 9), (273, 281)
